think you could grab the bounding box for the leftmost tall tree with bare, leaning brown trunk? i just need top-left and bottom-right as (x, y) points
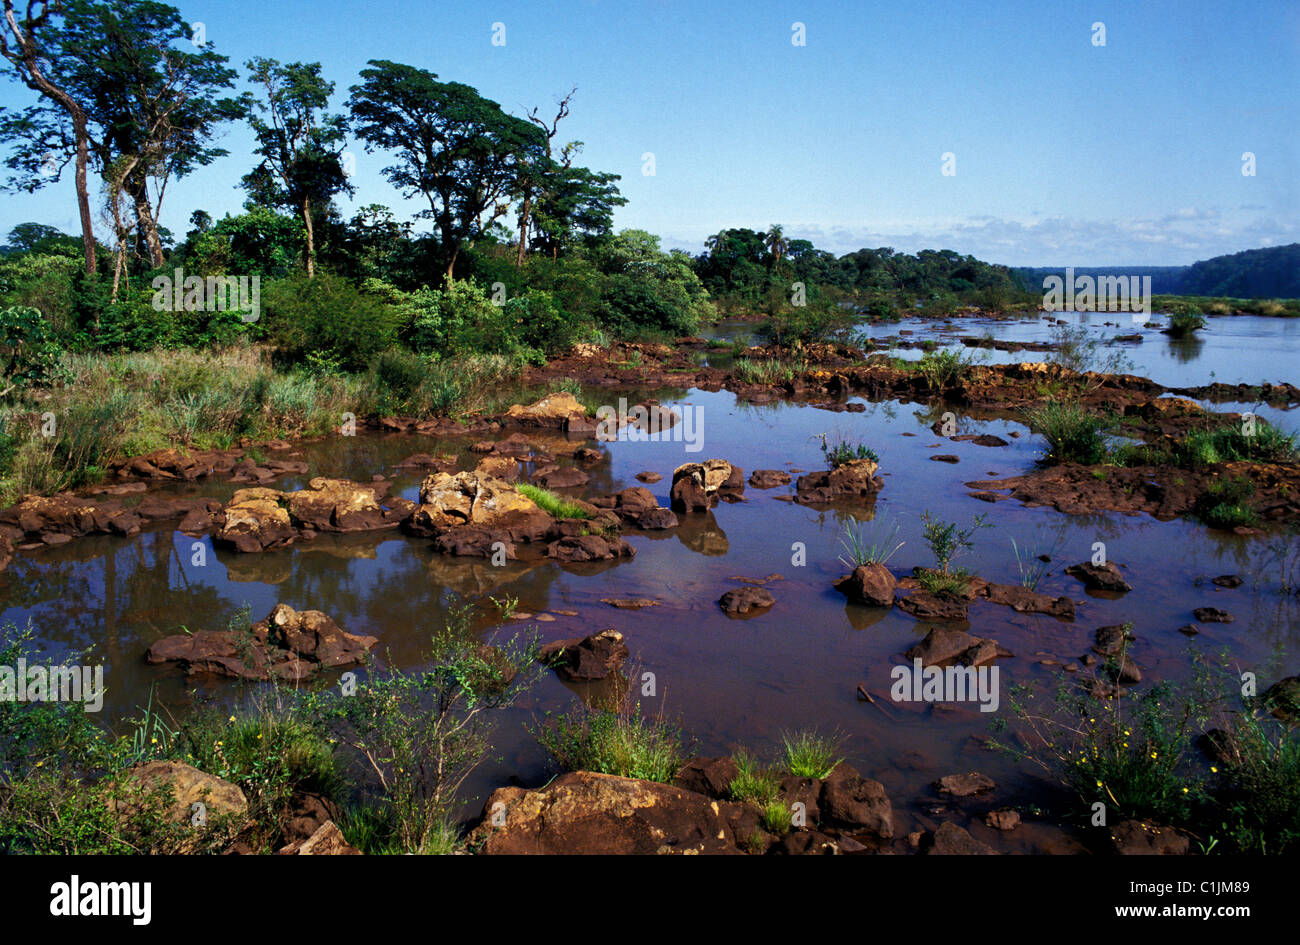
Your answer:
(0, 0), (96, 276)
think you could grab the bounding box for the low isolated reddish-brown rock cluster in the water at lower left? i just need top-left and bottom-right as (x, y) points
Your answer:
(146, 604), (380, 682)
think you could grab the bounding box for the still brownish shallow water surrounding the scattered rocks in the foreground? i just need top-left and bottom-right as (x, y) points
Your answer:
(0, 371), (1300, 845)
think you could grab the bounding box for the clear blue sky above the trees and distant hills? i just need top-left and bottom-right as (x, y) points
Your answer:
(0, 0), (1300, 265)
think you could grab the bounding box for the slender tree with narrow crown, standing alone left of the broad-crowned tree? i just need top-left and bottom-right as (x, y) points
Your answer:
(243, 58), (354, 277)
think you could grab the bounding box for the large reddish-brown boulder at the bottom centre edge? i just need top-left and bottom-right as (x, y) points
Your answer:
(469, 771), (741, 854)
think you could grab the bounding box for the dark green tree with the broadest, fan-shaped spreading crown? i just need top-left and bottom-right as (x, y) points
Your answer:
(348, 60), (546, 282)
